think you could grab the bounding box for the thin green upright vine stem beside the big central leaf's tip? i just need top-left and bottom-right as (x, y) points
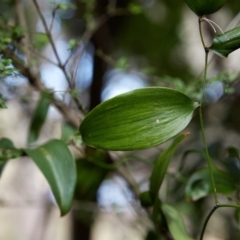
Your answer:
(198, 17), (218, 204)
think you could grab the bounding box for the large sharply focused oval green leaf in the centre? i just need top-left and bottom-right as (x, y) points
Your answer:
(80, 88), (196, 150)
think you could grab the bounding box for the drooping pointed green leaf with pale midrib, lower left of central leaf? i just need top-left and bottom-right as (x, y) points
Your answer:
(25, 140), (77, 216)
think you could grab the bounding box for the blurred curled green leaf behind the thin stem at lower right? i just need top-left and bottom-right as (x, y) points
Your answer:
(185, 168), (236, 201)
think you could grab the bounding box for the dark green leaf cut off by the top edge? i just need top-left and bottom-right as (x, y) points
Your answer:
(185, 0), (226, 17)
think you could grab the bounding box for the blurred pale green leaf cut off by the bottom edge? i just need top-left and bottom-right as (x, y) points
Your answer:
(162, 204), (193, 240)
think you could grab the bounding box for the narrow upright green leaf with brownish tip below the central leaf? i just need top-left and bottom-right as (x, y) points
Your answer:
(150, 133), (188, 200)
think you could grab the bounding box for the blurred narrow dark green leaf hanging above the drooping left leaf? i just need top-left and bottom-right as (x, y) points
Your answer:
(28, 92), (51, 143)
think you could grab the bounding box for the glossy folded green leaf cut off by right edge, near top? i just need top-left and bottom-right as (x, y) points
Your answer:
(209, 27), (240, 57)
